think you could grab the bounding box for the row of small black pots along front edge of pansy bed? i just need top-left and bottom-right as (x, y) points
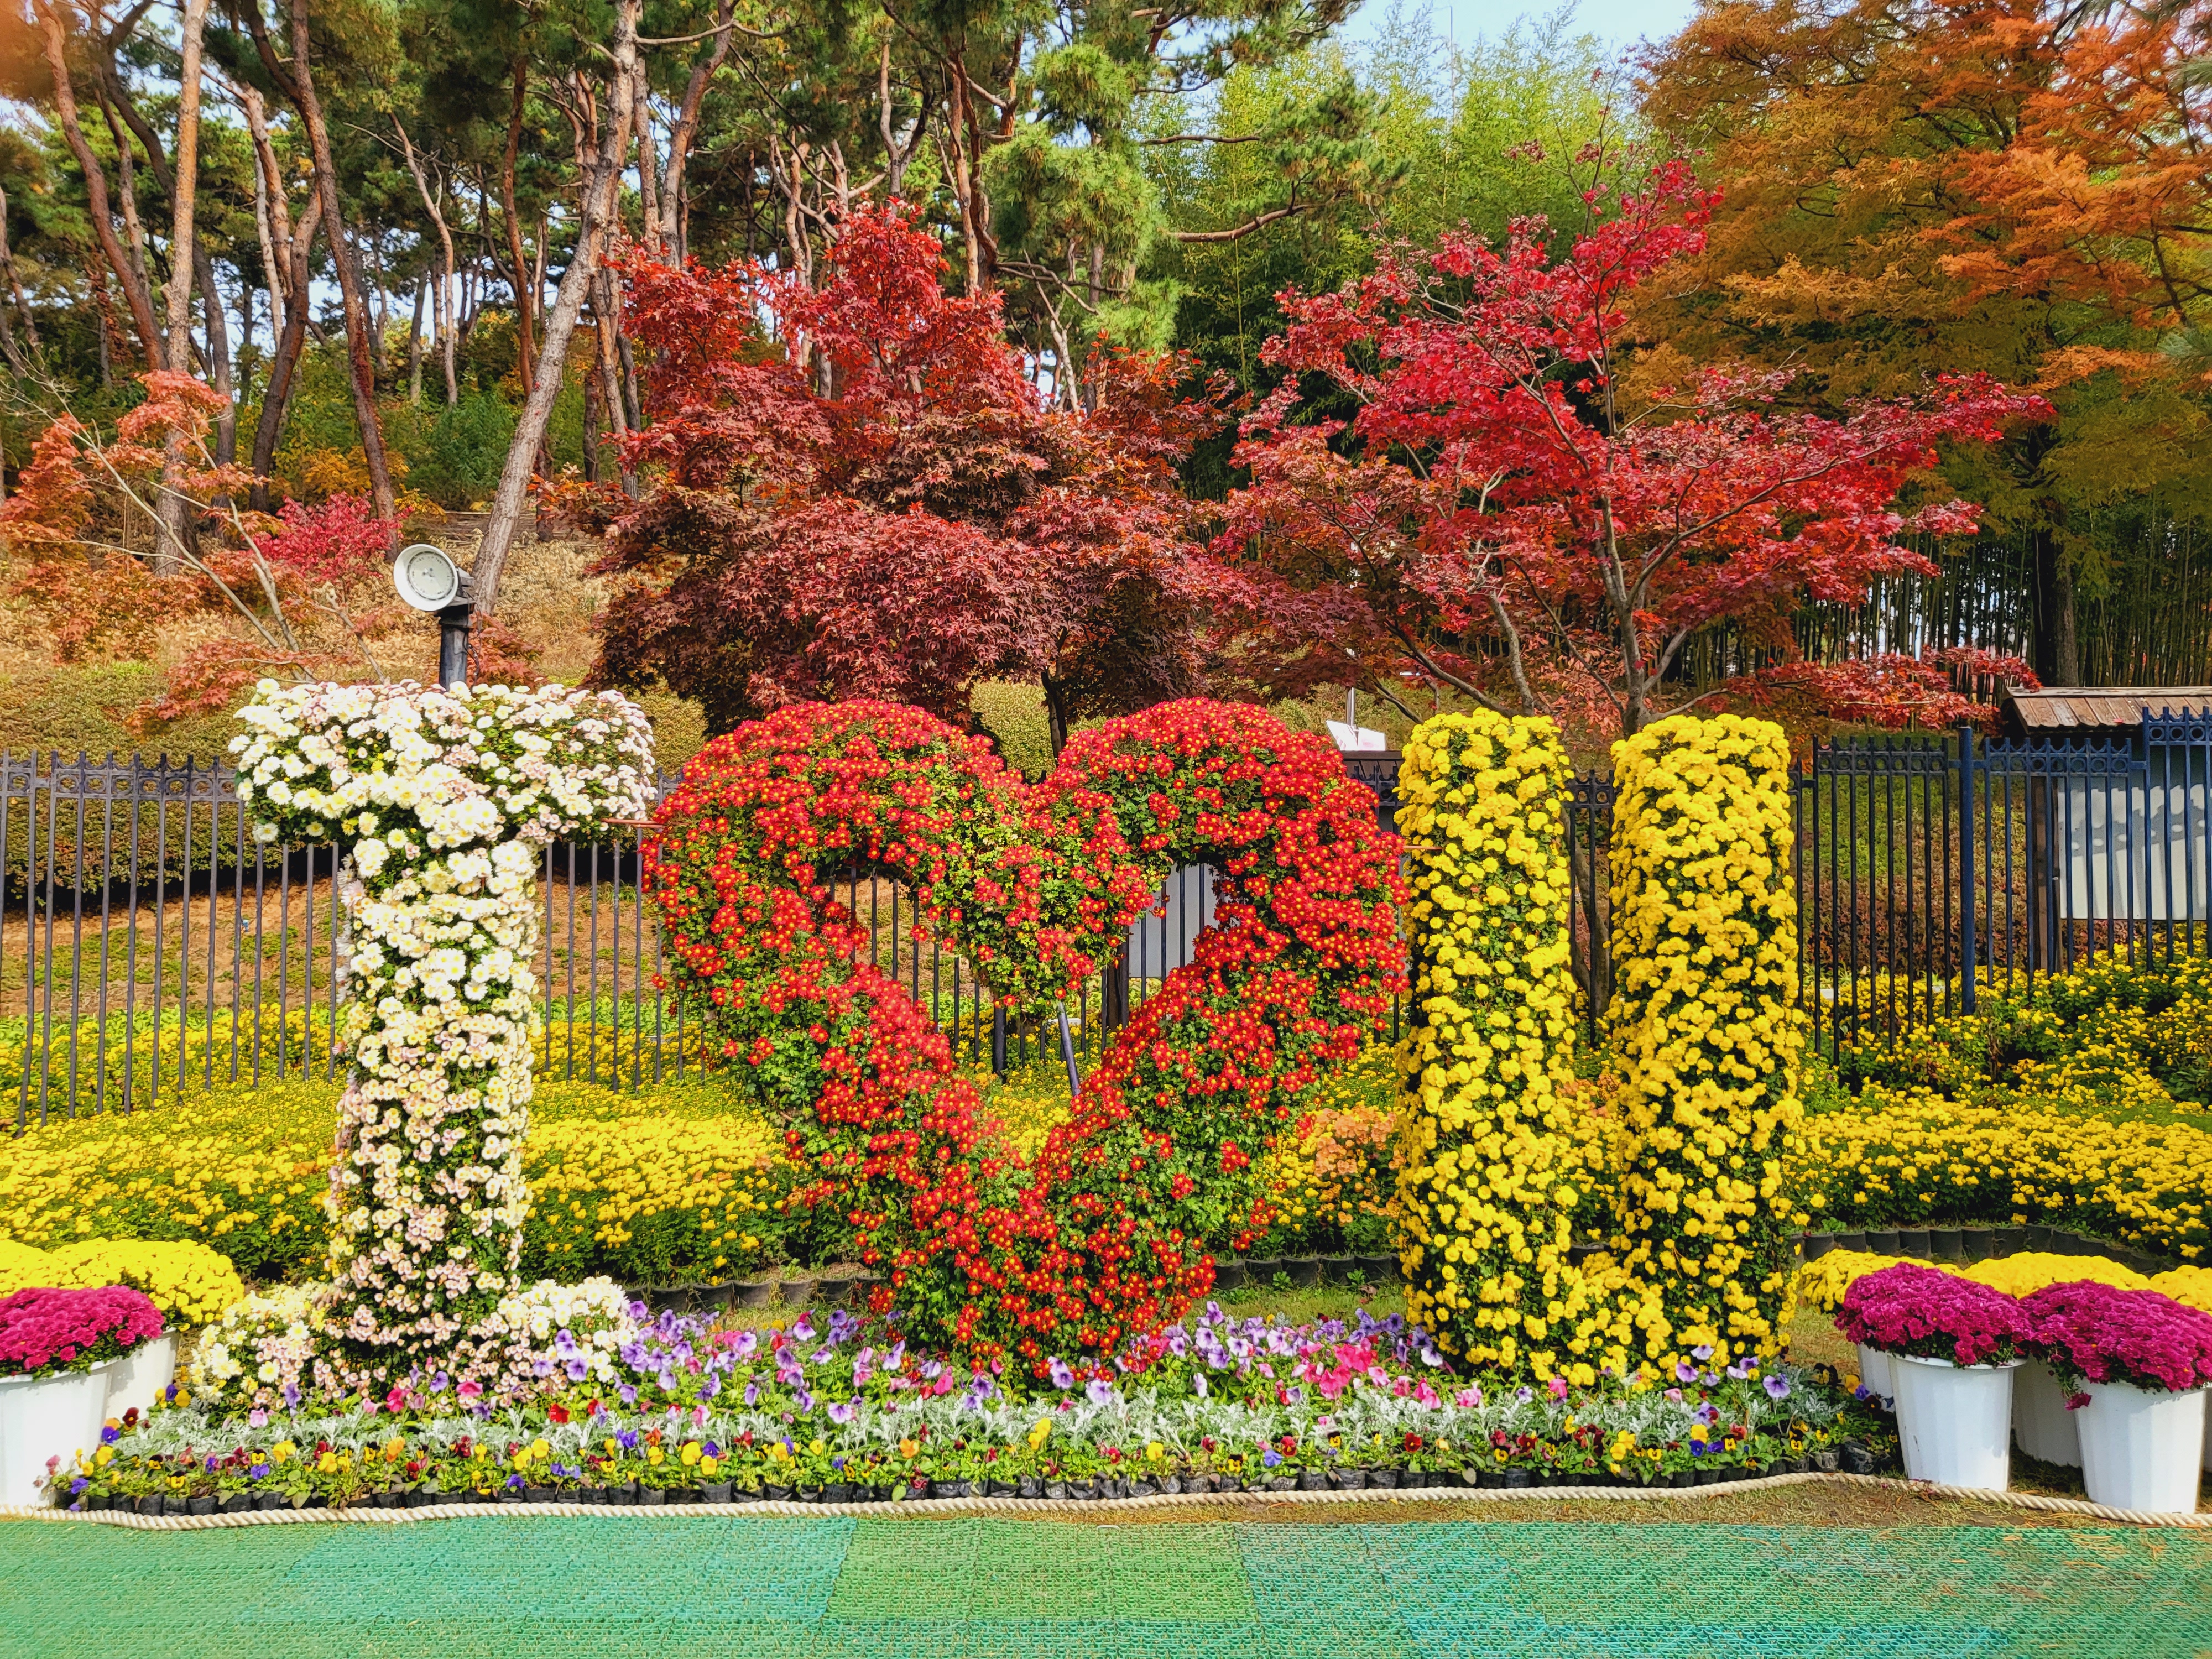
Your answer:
(60, 1440), (1882, 1515)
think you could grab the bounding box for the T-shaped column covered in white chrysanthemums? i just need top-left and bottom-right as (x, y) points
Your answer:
(232, 681), (653, 1391)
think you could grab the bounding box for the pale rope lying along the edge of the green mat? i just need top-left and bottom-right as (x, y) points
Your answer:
(0, 1471), (2212, 1533)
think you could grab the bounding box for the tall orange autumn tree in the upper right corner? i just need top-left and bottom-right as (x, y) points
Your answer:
(1637, 0), (2212, 684)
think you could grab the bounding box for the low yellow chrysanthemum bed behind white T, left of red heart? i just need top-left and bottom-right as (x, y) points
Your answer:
(0, 1082), (796, 1283)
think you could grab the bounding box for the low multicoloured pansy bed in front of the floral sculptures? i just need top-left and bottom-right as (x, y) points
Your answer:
(58, 1303), (1876, 1513)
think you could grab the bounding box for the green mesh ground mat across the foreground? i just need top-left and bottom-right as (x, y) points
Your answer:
(0, 1513), (2212, 1659)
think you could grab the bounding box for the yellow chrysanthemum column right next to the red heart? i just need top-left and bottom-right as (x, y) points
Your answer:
(1398, 712), (1628, 1383)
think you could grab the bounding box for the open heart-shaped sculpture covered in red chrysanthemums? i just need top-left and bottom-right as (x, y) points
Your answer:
(646, 701), (1405, 1360)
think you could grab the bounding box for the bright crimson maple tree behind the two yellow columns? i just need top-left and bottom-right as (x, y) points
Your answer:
(1214, 157), (2048, 732)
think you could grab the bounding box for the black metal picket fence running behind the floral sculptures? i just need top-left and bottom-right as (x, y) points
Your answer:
(0, 712), (2212, 1121)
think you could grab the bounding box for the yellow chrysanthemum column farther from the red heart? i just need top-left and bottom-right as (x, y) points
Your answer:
(1608, 714), (1805, 1367)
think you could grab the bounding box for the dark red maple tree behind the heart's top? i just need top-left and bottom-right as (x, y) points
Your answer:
(595, 204), (1223, 748)
